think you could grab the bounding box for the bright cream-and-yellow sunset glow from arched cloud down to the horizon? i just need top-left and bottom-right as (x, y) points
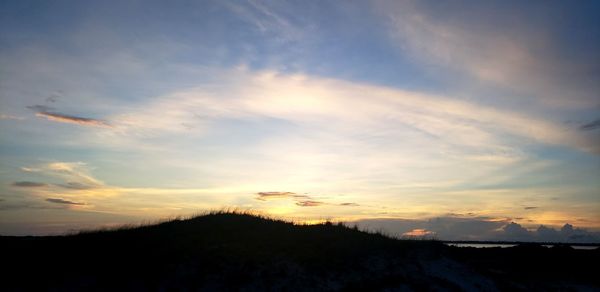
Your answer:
(2, 69), (597, 230)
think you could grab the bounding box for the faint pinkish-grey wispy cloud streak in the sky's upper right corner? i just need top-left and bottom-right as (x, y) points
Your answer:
(378, 1), (600, 109)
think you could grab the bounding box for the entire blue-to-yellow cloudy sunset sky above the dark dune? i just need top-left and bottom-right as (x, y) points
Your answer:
(0, 0), (600, 242)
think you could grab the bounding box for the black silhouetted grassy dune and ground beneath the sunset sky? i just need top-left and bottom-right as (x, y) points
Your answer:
(0, 213), (600, 291)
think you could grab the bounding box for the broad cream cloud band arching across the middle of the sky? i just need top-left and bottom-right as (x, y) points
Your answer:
(125, 70), (600, 155)
